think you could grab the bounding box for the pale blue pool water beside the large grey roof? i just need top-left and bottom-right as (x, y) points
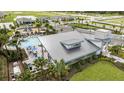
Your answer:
(21, 37), (41, 48)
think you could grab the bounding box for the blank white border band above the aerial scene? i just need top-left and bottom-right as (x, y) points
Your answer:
(0, 0), (124, 11)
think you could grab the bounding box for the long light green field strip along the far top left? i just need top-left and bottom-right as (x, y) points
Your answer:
(0, 11), (86, 22)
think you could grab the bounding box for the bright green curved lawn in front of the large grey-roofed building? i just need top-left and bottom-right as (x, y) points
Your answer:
(70, 61), (124, 81)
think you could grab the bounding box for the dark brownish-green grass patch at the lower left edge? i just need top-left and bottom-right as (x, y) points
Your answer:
(0, 56), (7, 81)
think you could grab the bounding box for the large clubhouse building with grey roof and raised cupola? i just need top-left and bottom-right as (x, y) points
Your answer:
(39, 31), (107, 64)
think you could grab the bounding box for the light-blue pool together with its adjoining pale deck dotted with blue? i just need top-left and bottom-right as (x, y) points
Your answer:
(20, 36), (42, 64)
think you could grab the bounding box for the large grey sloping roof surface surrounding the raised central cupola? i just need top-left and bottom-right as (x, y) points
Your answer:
(39, 31), (99, 63)
